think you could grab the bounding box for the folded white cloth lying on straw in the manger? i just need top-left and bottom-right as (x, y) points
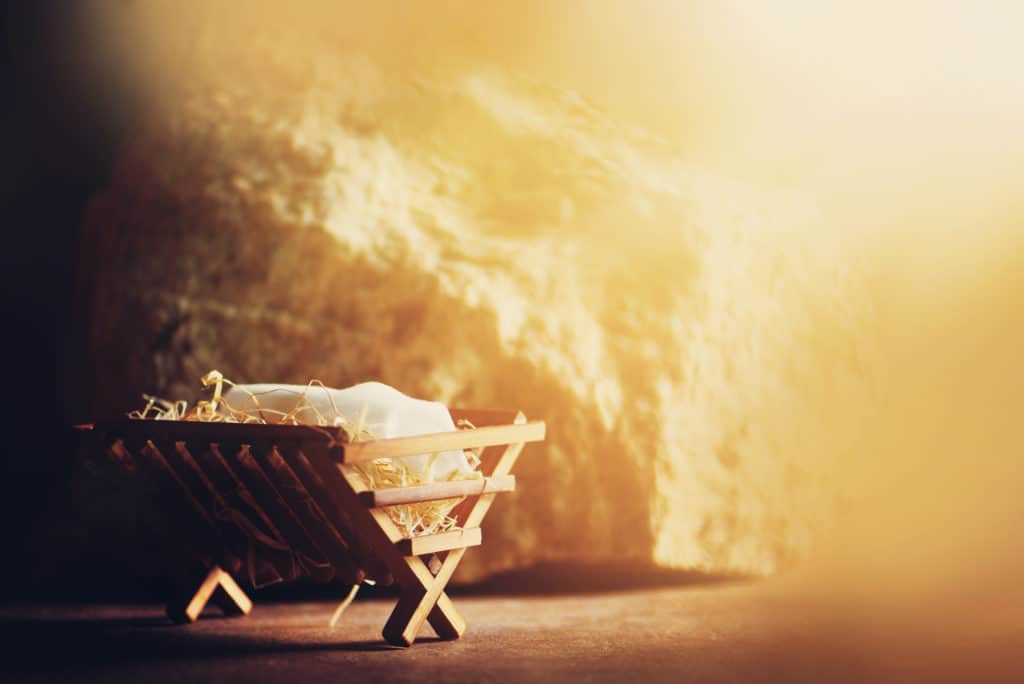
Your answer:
(224, 382), (473, 481)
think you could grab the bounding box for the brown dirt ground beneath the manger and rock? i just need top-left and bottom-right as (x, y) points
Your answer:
(0, 582), (1024, 684)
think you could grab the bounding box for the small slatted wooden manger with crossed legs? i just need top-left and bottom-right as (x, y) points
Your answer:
(80, 409), (545, 646)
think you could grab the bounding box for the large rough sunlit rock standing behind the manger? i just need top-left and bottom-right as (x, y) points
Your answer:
(74, 42), (869, 579)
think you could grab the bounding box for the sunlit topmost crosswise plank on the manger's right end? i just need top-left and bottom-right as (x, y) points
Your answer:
(342, 421), (545, 464)
